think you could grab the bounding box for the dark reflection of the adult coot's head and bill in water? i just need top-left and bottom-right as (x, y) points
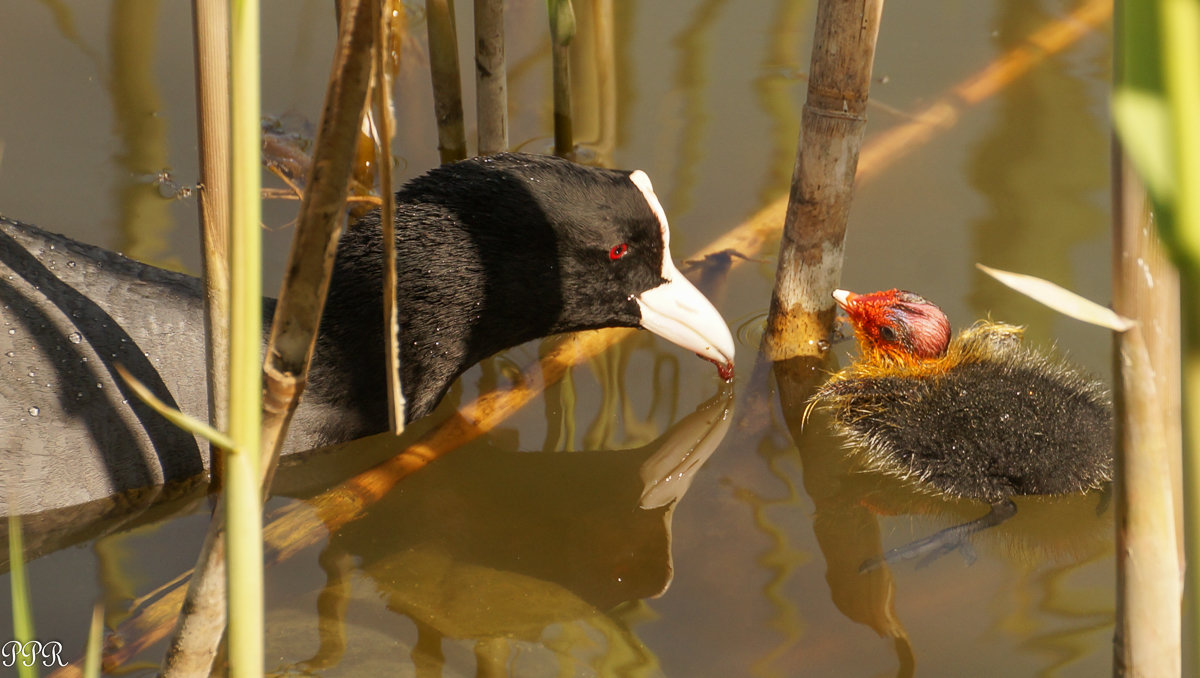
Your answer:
(270, 388), (732, 674)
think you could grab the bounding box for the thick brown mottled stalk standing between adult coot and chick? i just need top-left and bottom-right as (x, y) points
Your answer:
(763, 0), (883, 361)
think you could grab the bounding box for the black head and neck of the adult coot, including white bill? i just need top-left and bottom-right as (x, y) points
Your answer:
(313, 154), (734, 433)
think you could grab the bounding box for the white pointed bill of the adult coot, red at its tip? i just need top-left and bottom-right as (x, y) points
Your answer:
(634, 265), (733, 379)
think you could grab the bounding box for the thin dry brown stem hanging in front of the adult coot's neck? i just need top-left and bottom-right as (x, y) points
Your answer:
(374, 1), (404, 436)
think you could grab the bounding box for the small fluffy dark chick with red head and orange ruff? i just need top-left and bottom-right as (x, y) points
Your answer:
(812, 289), (1112, 504)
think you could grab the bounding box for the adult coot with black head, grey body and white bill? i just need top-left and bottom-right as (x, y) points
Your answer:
(0, 154), (733, 512)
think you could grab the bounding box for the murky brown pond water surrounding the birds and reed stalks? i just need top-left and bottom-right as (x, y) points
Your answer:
(0, 0), (1114, 677)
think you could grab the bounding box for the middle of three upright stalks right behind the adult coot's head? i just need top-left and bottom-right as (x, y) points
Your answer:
(475, 0), (509, 155)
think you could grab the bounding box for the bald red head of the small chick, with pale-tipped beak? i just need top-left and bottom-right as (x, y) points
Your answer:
(833, 289), (950, 359)
